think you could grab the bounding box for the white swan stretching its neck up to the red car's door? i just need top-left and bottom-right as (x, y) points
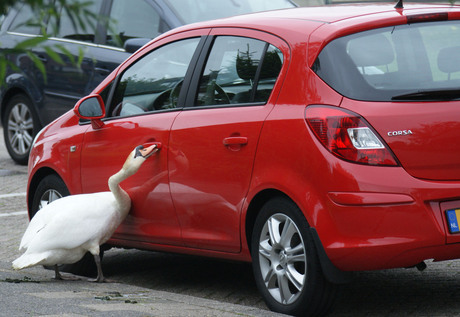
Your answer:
(13, 144), (158, 282)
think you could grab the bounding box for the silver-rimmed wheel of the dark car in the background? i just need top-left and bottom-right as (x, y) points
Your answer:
(3, 94), (41, 165)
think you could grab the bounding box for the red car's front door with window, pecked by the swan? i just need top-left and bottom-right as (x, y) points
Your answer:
(81, 37), (200, 245)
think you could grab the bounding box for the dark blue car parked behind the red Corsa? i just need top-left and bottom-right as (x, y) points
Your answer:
(0, 0), (295, 164)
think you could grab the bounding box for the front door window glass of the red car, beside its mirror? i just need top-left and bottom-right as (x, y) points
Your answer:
(109, 38), (200, 116)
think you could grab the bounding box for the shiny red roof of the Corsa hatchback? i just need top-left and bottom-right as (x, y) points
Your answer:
(149, 2), (460, 66)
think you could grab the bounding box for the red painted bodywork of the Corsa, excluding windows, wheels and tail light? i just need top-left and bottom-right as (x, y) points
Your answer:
(28, 5), (460, 271)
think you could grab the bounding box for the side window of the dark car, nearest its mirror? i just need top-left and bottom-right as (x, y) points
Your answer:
(107, 0), (162, 46)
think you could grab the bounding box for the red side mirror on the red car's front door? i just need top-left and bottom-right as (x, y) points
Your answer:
(73, 95), (105, 129)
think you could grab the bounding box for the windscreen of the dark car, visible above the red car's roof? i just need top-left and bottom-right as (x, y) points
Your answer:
(166, 0), (295, 24)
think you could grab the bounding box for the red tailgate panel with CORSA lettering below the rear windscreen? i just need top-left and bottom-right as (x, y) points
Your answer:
(342, 99), (460, 181)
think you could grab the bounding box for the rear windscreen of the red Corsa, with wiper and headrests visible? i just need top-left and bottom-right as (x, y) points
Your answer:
(313, 21), (460, 101)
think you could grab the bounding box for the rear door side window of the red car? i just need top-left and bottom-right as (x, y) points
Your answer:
(195, 36), (283, 106)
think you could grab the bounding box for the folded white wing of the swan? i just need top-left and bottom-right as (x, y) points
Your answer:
(21, 192), (116, 252)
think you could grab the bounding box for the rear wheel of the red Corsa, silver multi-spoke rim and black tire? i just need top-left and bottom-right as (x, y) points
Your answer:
(251, 197), (338, 316)
